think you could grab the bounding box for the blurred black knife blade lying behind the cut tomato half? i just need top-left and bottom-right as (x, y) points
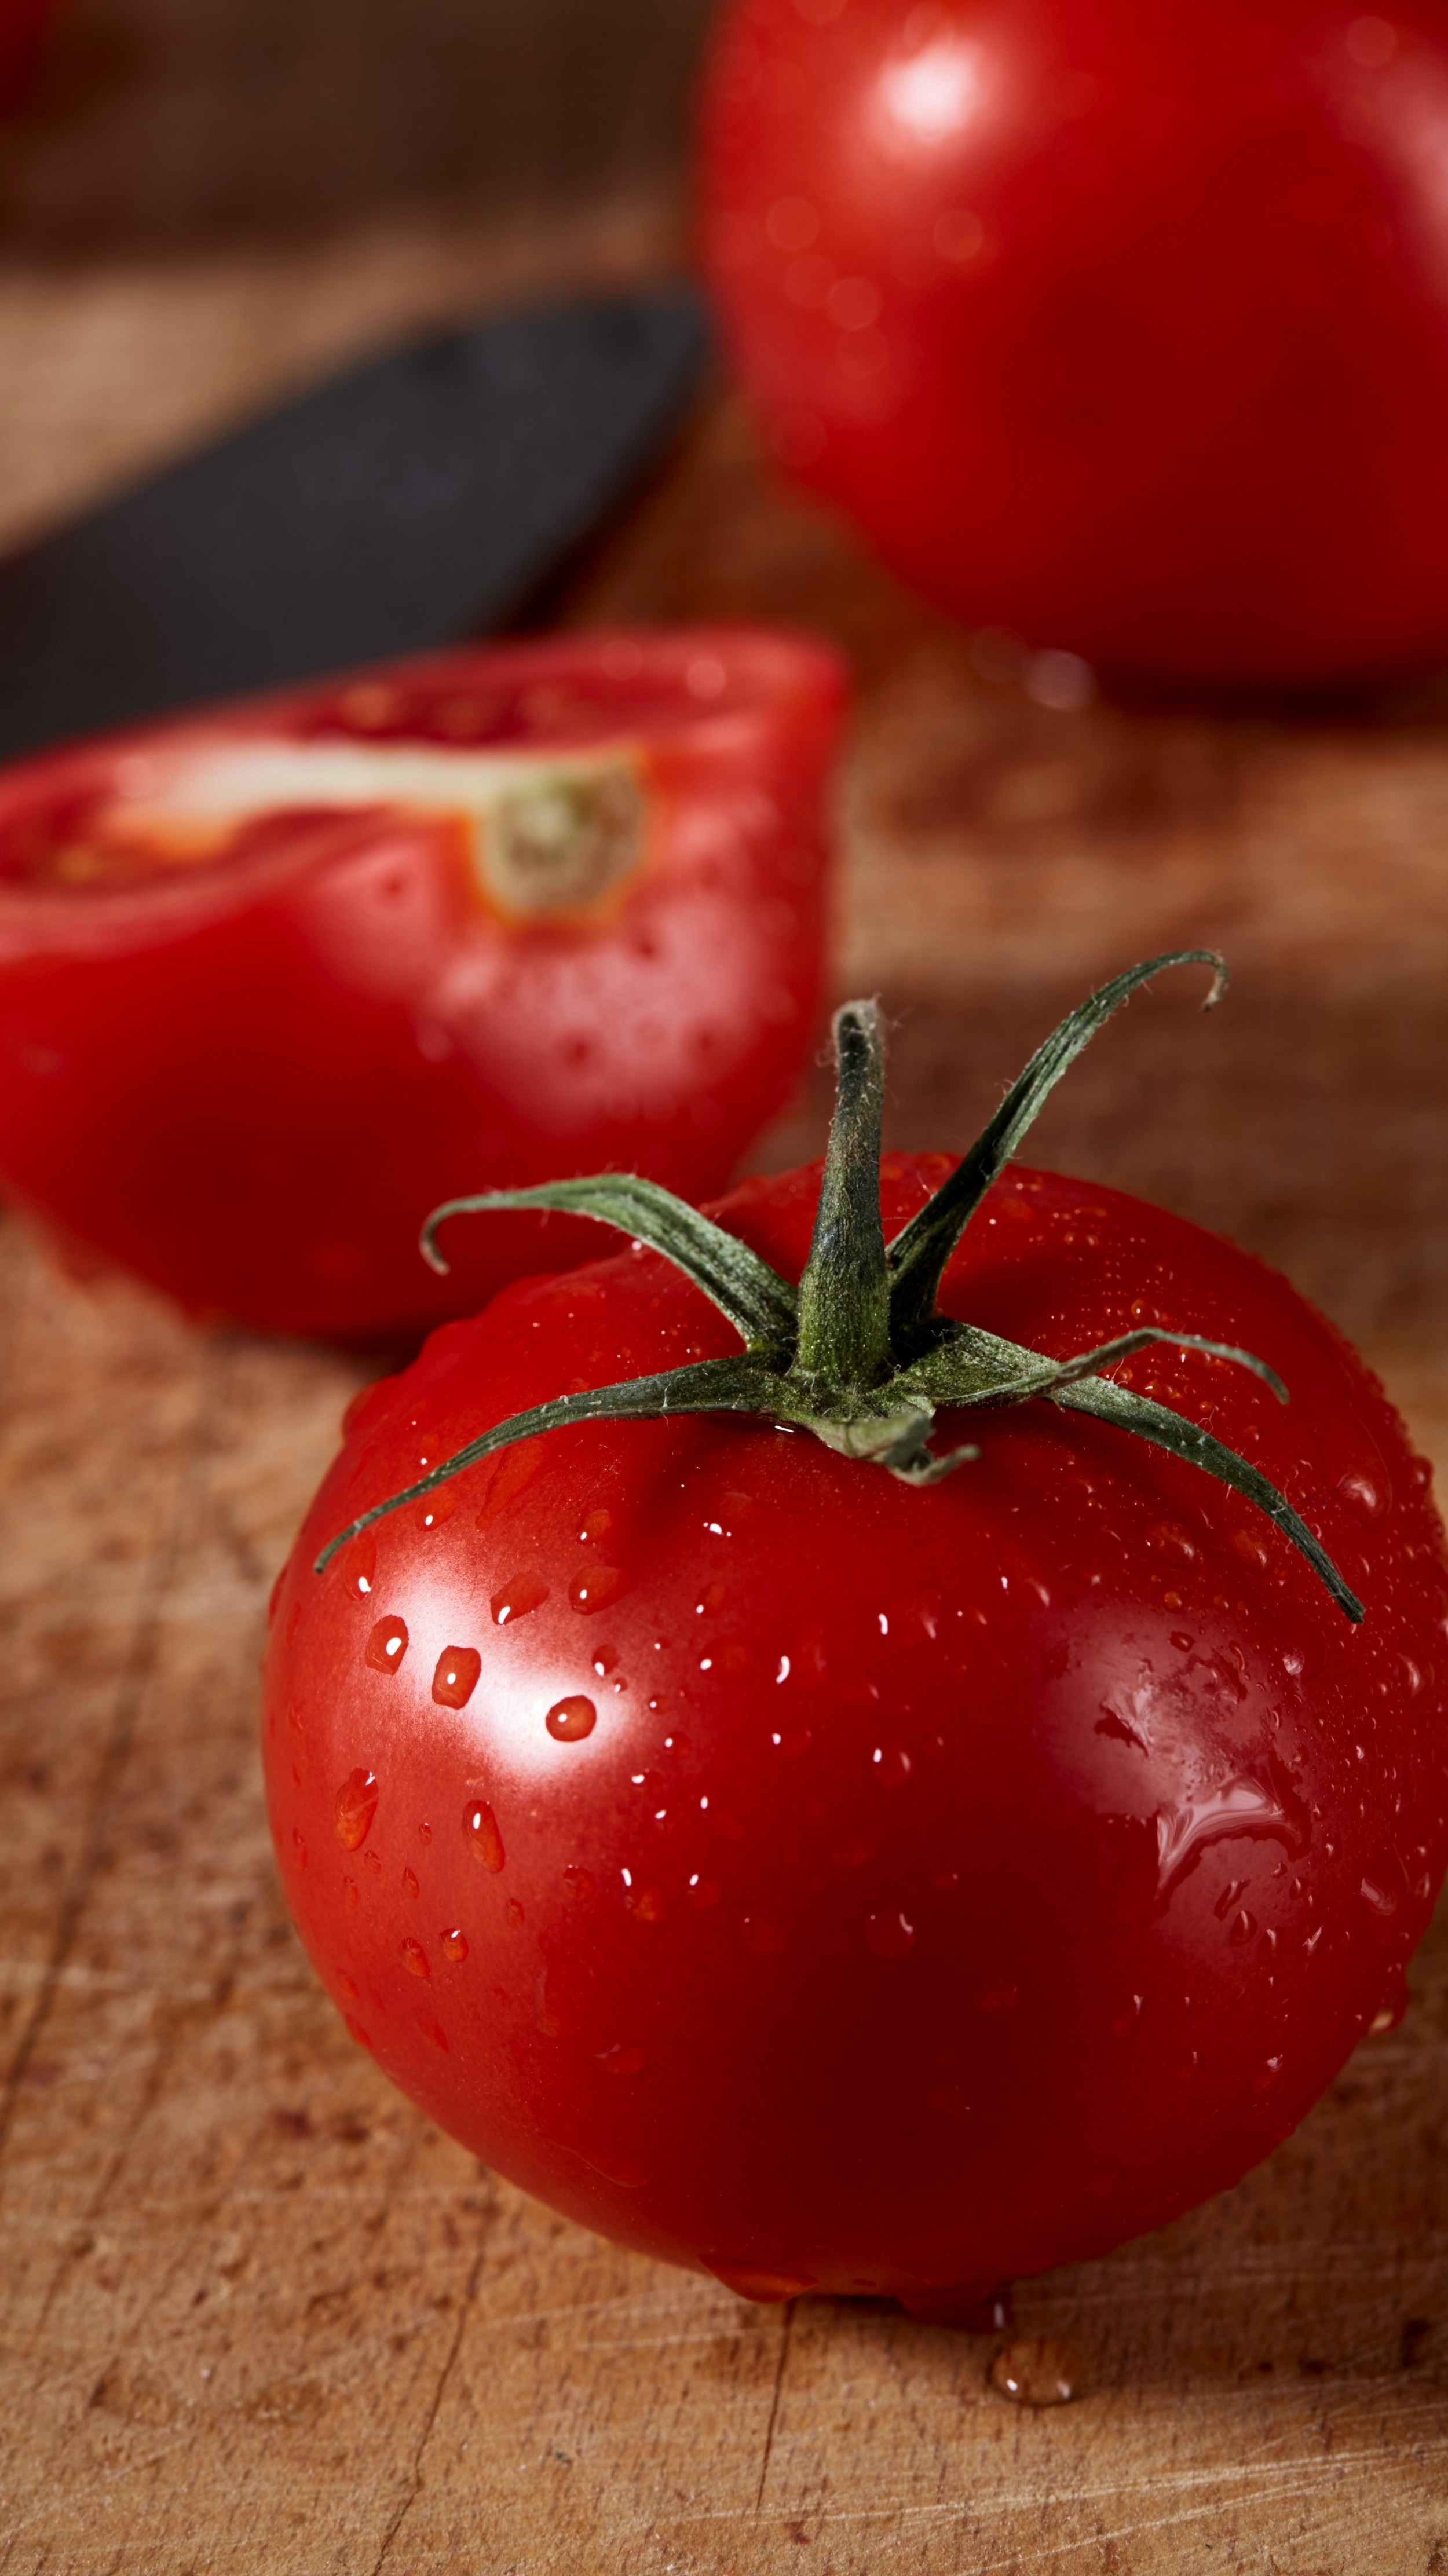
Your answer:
(0, 288), (708, 758)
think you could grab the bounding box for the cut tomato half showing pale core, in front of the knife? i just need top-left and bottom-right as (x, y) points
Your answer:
(0, 628), (843, 1340)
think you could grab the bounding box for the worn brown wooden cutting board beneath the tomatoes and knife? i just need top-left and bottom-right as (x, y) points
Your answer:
(0, 0), (1448, 2576)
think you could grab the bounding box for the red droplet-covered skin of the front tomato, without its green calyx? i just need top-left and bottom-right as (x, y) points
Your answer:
(265, 1157), (1448, 2306)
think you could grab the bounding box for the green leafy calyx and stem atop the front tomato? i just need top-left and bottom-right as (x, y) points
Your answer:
(315, 948), (1363, 1620)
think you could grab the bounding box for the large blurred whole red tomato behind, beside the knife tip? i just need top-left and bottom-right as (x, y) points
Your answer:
(703, 0), (1448, 685)
